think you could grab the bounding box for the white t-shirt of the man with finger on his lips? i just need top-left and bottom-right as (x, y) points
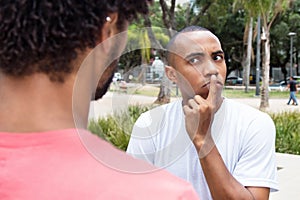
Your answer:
(127, 98), (278, 199)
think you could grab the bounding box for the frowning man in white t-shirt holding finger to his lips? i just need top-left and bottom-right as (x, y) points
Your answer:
(127, 26), (278, 200)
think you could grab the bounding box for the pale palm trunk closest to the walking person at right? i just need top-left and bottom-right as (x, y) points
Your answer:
(259, 26), (270, 111)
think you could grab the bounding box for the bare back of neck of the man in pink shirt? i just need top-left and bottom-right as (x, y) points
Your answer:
(0, 74), (88, 133)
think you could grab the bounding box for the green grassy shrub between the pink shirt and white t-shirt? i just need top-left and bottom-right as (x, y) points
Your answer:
(88, 105), (150, 151)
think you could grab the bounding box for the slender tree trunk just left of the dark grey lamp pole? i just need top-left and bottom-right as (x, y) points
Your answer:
(242, 17), (253, 92)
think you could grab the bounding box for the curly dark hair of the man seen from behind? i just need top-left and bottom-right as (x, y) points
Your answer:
(0, 0), (150, 81)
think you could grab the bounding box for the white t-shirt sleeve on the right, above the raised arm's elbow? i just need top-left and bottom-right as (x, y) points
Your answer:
(233, 114), (278, 191)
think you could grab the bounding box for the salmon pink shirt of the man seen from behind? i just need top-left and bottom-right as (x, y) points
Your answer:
(0, 129), (197, 200)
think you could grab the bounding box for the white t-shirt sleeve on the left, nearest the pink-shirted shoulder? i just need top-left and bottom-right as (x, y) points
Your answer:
(126, 113), (156, 164)
